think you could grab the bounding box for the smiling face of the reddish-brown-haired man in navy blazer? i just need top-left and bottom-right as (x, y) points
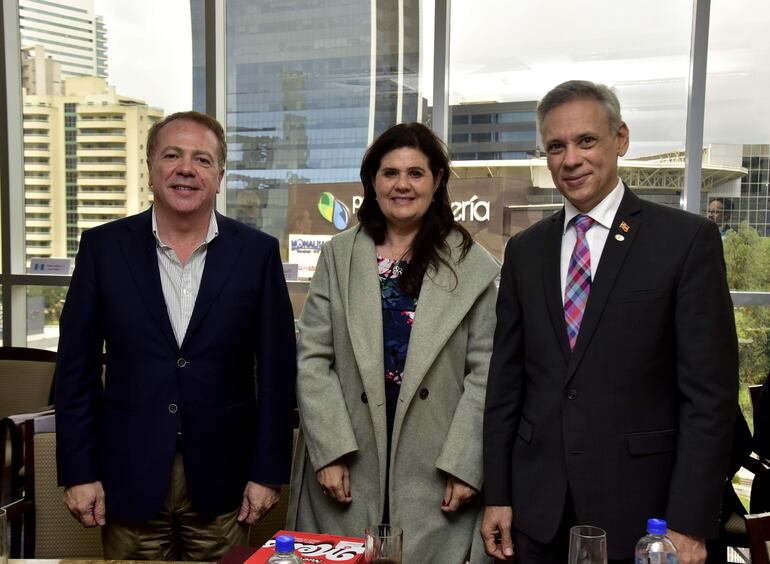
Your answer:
(150, 119), (225, 220)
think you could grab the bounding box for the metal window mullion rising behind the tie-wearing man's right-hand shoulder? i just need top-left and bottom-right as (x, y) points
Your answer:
(680, 0), (711, 213)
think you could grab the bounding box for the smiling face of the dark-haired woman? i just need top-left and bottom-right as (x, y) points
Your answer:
(374, 147), (444, 236)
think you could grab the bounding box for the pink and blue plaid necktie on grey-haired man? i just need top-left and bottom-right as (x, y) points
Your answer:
(564, 215), (594, 349)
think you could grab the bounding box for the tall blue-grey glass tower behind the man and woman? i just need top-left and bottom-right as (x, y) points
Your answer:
(190, 0), (422, 237)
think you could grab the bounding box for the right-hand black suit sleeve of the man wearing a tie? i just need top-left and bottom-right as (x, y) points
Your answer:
(666, 222), (738, 538)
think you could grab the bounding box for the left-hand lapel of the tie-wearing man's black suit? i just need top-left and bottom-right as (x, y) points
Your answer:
(543, 208), (571, 362)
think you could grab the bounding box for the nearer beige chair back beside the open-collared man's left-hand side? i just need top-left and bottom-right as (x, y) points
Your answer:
(24, 415), (104, 559)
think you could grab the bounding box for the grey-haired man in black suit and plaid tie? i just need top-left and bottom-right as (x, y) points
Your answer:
(481, 81), (738, 564)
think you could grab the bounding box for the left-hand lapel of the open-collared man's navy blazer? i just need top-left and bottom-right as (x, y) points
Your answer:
(120, 209), (178, 350)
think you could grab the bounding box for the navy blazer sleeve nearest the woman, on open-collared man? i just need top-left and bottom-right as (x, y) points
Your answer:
(250, 236), (297, 484)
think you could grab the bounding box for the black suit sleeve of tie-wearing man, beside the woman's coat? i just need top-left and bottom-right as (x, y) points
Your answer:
(483, 238), (525, 505)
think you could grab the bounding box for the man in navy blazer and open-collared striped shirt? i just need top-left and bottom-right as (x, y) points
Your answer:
(56, 112), (296, 560)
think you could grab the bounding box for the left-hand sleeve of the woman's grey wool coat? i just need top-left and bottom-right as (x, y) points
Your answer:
(297, 244), (358, 471)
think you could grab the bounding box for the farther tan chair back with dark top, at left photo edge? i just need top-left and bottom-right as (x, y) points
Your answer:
(0, 347), (56, 419)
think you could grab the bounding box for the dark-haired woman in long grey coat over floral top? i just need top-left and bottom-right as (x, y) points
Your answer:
(288, 123), (499, 564)
